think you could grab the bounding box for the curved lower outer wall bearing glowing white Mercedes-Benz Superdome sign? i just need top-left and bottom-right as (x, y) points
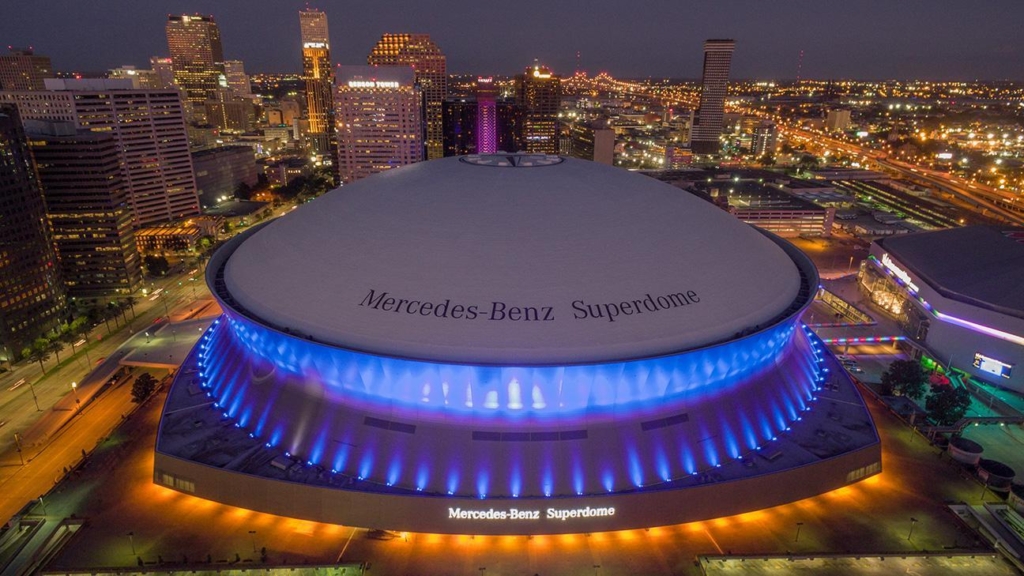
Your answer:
(155, 444), (881, 535)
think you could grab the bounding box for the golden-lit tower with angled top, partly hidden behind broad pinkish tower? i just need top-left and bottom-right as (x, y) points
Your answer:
(368, 34), (447, 160)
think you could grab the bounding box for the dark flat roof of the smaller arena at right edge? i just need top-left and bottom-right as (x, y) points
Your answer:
(878, 225), (1024, 318)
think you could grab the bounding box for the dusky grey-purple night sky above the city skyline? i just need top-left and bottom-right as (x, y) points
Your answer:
(0, 0), (1024, 80)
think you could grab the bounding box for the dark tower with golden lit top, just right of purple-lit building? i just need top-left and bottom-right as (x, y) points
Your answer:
(515, 61), (562, 154)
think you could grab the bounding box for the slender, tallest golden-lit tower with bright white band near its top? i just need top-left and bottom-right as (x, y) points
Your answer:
(299, 8), (334, 157)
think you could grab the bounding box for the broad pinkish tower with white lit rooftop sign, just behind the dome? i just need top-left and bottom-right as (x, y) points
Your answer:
(334, 66), (423, 182)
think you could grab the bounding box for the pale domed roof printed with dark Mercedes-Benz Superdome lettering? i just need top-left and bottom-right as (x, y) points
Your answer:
(224, 156), (801, 365)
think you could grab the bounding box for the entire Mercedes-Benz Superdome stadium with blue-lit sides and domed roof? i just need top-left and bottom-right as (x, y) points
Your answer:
(155, 155), (881, 534)
